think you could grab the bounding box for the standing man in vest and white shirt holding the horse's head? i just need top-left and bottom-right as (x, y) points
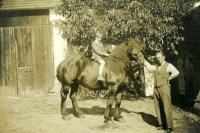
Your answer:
(144, 52), (179, 133)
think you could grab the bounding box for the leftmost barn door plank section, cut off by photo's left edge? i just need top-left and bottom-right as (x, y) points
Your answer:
(0, 28), (17, 95)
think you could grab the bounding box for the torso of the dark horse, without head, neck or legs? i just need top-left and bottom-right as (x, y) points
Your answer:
(56, 55), (126, 89)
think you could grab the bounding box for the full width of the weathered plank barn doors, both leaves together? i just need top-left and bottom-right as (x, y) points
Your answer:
(0, 25), (55, 95)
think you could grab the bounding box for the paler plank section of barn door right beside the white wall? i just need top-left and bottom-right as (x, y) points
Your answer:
(32, 25), (55, 92)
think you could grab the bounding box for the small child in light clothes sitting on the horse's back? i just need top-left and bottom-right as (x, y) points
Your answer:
(92, 31), (110, 81)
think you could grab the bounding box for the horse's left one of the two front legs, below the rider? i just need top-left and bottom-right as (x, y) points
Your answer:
(104, 89), (115, 123)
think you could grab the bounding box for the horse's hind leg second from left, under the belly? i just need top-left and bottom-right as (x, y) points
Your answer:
(70, 83), (85, 118)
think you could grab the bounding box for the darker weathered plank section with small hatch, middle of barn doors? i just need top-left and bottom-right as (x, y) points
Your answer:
(14, 26), (35, 95)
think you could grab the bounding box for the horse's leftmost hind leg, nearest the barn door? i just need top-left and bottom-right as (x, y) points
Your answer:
(60, 85), (70, 120)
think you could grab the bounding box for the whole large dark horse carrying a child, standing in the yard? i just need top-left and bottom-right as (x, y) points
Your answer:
(56, 39), (144, 122)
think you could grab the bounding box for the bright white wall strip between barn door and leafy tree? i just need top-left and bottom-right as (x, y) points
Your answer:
(49, 9), (67, 93)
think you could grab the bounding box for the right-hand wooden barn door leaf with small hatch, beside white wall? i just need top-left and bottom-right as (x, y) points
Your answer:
(15, 25), (54, 95)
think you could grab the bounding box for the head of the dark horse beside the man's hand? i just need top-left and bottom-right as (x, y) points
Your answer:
(126, 38), (144, 66)
